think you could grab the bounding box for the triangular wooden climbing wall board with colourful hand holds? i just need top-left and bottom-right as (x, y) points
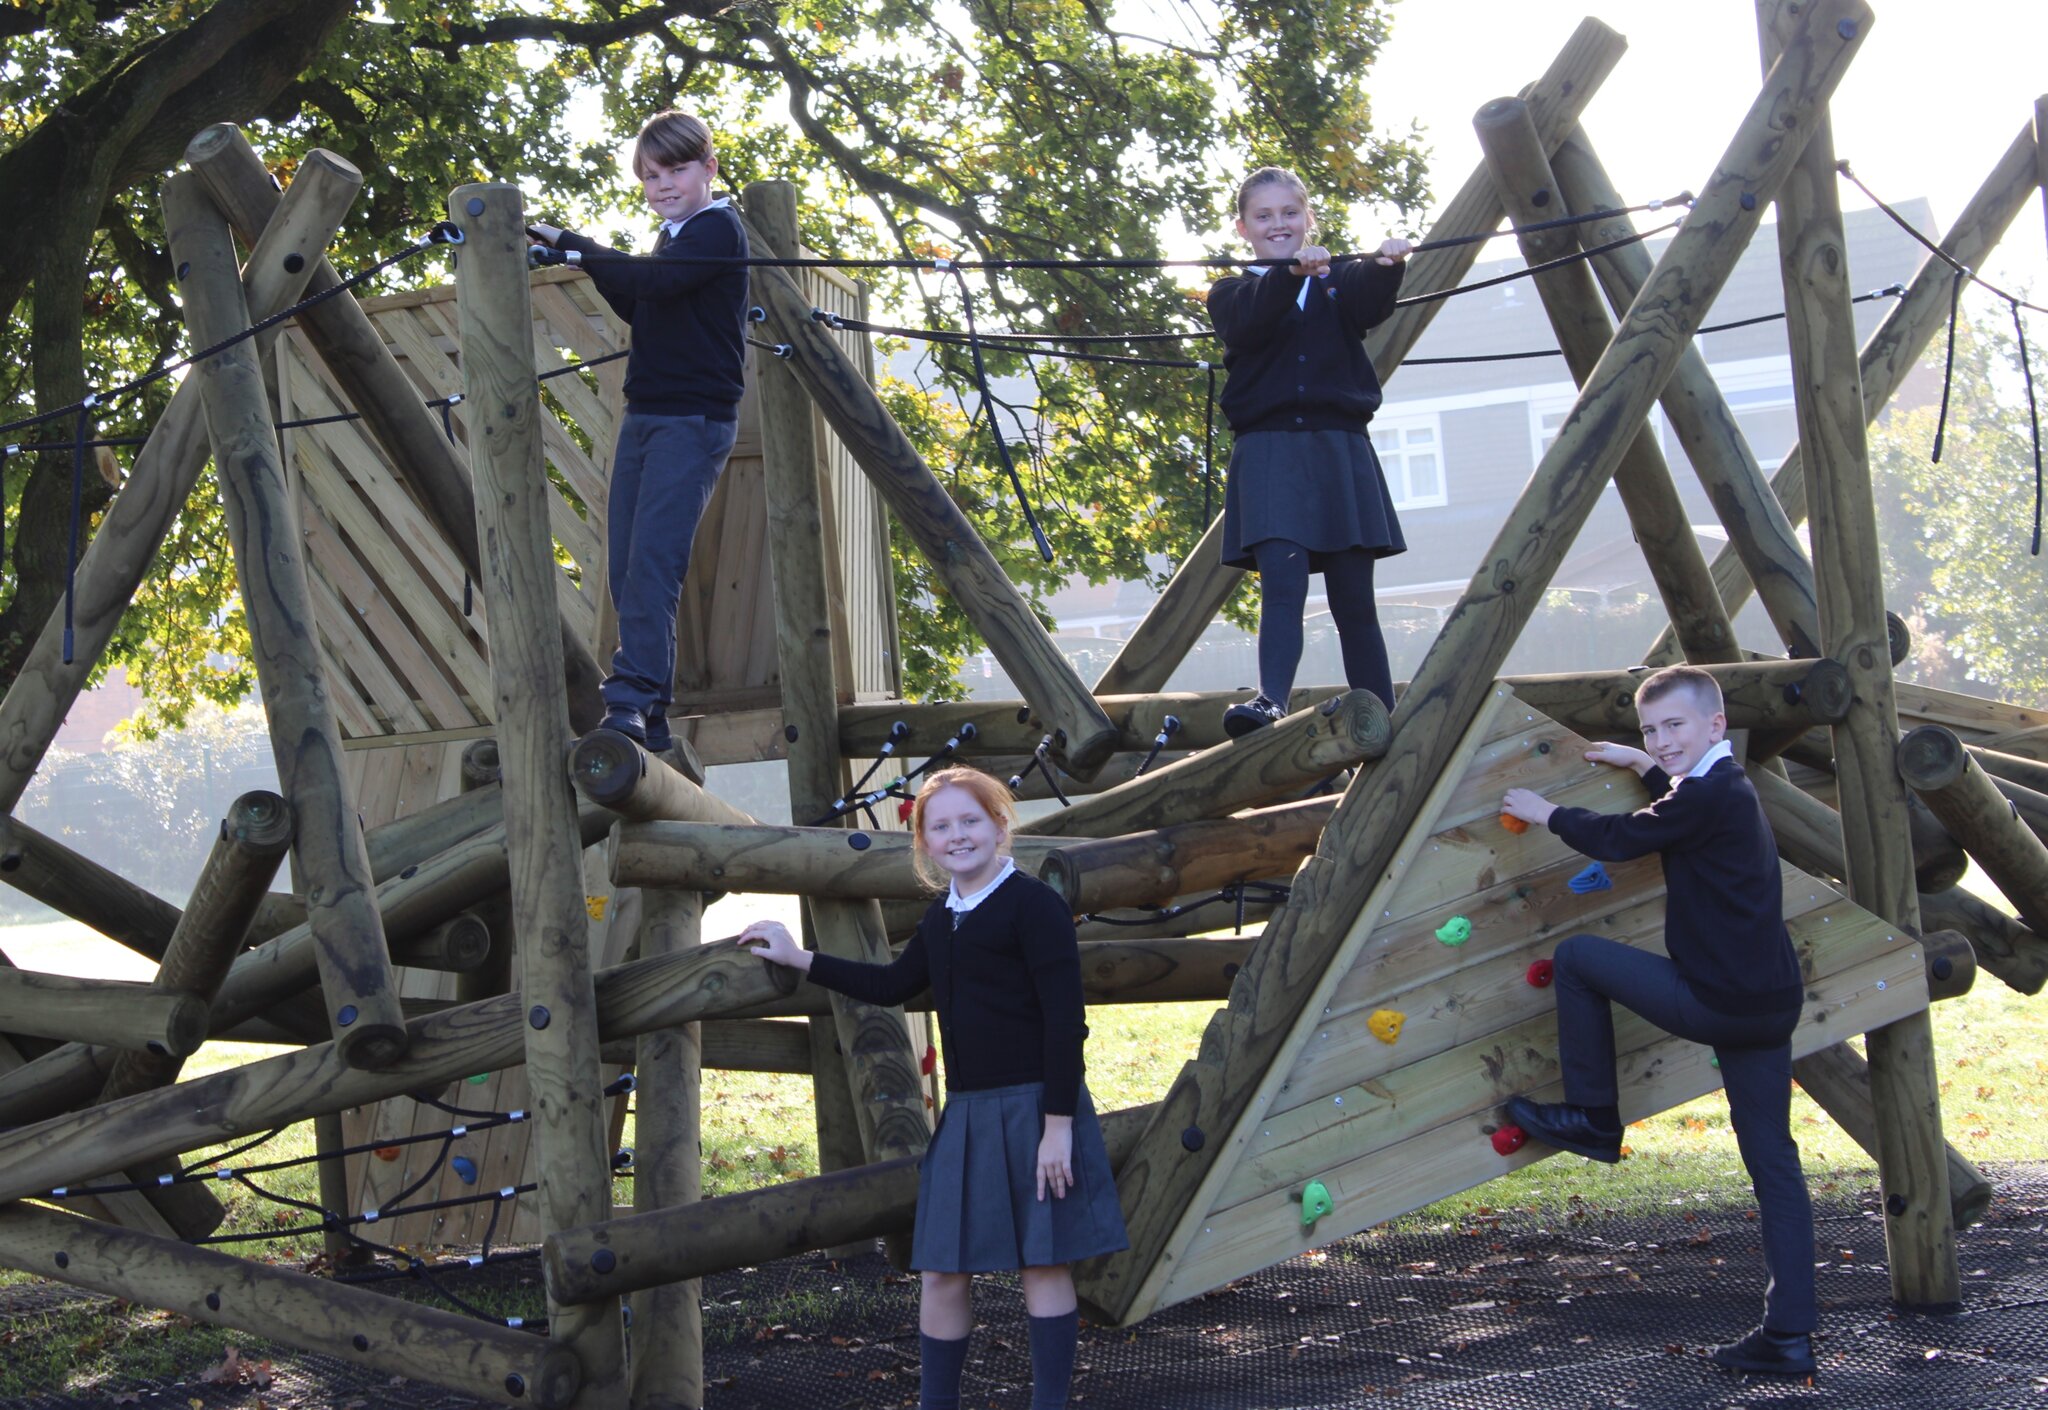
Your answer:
(1147, 697), (1927, 1310)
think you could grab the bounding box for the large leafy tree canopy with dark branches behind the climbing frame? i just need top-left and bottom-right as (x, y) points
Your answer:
(0, 0), (1423, 719)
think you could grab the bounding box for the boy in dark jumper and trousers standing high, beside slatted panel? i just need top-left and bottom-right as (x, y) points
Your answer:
(528, 111), (748, 754)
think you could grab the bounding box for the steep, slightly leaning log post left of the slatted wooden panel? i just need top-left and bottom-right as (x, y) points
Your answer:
(164, 172), (406, 1068)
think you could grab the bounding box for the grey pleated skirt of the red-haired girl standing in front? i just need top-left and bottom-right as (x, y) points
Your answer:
(909, 1082), (1130, 1273)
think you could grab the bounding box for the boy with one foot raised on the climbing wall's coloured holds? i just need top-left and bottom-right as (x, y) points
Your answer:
(1501, 666), (1817, 1377)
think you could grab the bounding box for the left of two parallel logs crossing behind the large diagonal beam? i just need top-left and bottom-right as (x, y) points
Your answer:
(1473, 98), (1741, 664)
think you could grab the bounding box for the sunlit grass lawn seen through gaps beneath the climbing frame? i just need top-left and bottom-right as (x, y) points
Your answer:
(0, 881), (2048, 1398)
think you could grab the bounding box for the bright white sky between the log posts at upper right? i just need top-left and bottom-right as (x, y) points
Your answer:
(1360, 0), (2048, 295)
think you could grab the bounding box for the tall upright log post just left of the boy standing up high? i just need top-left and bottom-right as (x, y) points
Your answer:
(449, 182), (627, 1406)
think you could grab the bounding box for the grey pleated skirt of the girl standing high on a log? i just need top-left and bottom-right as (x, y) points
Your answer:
(1223, 430), (1407, 572)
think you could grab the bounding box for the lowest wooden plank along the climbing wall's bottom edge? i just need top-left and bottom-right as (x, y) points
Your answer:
(1157, 945), (1927, 1305)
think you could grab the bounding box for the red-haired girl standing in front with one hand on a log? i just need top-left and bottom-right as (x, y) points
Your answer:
(739, 769), (1128, 1410)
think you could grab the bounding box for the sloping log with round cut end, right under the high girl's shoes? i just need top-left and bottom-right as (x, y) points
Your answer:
(1018, 691), (1389, 836)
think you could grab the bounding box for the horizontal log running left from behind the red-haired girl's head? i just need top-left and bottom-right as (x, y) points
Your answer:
(610, 822), (1057, 904)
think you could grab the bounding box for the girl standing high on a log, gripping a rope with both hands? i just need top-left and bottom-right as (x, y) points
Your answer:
(1208, 166), (1411, 736)
